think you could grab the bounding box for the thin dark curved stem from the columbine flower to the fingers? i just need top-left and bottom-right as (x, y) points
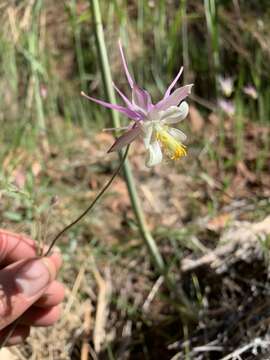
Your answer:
(43, 145), (130, 256)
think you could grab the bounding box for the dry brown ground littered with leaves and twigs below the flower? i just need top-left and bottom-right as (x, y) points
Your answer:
(2, 111), (270, 359)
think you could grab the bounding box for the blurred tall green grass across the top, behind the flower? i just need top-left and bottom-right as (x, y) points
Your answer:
(0, 0), (270, 141)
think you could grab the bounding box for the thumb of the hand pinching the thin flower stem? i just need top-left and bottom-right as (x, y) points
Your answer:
(0, 258), (56, 330)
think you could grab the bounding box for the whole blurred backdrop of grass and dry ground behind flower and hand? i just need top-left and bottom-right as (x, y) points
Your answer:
(0, 0), (270, 360)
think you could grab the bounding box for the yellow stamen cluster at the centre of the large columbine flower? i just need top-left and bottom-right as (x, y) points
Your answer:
(156, 129), (187, 160)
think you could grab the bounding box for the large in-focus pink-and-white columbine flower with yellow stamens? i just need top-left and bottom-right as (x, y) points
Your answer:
(82, 42), (192, 167)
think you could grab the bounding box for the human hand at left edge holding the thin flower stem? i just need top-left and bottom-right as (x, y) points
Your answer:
(0, 229), (64, 345)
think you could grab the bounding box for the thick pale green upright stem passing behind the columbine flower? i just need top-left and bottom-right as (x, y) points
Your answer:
(90, 0), (165, 274)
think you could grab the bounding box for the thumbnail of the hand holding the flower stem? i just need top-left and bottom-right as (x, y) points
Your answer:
(15, 259), (51, 297)
